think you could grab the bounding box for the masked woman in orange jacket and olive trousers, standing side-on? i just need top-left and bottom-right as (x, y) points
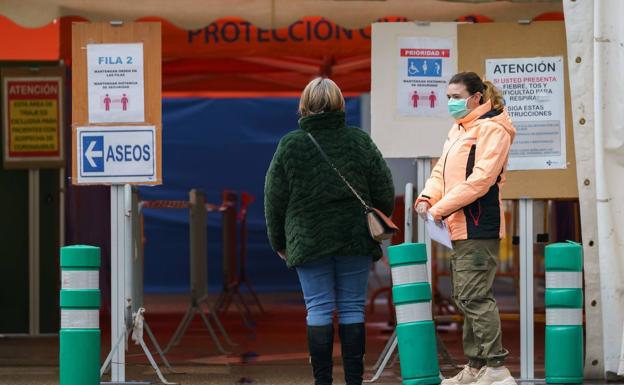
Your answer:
(415, 72), (515, 385)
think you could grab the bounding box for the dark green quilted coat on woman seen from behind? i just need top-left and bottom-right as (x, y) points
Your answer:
(264, 112), (394, 267)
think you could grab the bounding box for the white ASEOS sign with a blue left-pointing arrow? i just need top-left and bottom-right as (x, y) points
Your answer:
(76, 126), (158, 184)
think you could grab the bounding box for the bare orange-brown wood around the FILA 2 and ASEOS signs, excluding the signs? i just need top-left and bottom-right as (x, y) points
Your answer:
(72, 22), (162, 185)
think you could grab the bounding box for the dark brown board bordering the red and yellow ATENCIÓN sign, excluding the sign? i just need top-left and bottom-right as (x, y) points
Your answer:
(0, 66), (65, 169)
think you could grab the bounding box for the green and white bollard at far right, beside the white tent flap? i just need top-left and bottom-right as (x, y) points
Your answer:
(545, 242), (583, 384)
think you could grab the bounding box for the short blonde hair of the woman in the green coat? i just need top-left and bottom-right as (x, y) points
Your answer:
(299, 77), (345, 117)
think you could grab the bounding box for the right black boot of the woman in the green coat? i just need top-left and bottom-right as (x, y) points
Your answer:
(340, 323), (366, 385)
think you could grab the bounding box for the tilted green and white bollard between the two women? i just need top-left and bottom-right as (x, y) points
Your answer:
(388, 243), (441, 385)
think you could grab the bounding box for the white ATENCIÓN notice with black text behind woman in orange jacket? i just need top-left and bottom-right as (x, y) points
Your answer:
(486, 56), (567, 170)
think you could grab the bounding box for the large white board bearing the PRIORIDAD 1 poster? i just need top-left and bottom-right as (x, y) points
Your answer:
(370, 22), (457, 159)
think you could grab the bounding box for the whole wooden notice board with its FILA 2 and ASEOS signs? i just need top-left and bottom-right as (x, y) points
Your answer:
(72, 22), (162, 185)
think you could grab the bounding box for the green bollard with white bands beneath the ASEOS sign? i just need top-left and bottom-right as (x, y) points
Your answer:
(59, 246), (100, 385)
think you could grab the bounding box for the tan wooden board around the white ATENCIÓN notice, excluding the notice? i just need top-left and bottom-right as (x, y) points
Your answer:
(457, 21), (578, 199)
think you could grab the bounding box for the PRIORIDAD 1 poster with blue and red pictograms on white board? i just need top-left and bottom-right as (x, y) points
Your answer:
(396, 37), (455, 117)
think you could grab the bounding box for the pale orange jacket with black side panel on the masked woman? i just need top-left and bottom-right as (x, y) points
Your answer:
(416, 102), (516, 241)
